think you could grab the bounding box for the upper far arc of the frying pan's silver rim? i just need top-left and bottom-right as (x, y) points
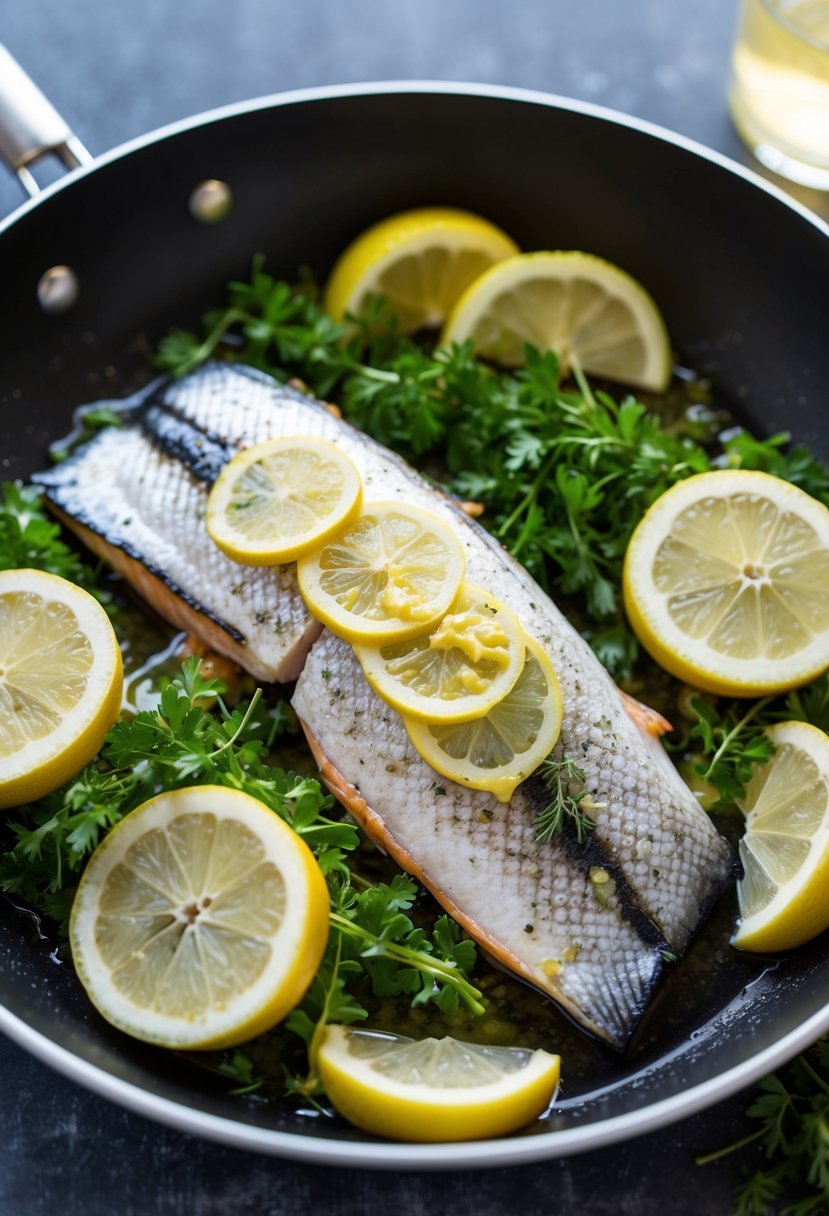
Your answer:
(0, 79), (829, 237)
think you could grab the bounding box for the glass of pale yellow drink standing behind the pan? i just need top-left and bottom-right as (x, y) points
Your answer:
(728, 0), (829, 190)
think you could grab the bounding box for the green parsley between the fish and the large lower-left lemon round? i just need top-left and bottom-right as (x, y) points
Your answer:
(0, 658), (484, 1093)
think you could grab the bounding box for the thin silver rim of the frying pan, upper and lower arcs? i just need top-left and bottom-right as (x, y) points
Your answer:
(0, 80), (829, 1170)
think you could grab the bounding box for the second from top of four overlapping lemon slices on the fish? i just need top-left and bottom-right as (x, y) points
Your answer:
(297, 502), (466, 643)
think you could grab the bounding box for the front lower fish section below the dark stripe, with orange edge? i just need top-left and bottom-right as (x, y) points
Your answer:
(293, 630), (666, 1048)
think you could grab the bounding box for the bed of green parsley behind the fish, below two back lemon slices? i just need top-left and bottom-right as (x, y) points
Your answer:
(156, 265), (829, 679)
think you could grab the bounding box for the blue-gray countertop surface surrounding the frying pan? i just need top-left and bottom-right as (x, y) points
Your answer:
(0, 0), (829, 1216)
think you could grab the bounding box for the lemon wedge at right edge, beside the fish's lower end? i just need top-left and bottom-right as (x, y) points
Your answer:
(732, 722), (829, 951)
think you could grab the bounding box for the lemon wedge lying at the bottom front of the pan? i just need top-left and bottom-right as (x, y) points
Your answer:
(317, 1026), (560, 1141)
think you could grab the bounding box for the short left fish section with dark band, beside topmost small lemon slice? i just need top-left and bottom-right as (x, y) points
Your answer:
(33, 386), (325, 682)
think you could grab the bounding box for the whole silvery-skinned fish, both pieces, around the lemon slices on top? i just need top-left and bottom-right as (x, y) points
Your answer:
(40, 364), (732, 1046)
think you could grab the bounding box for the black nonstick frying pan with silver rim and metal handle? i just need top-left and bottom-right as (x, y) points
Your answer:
(0, 47), (829, 1169)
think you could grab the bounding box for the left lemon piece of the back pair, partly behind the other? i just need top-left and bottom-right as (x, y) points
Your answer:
(323, 207), (518, 333)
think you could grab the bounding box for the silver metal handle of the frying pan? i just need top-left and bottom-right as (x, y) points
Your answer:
(0, 44), (92, 198)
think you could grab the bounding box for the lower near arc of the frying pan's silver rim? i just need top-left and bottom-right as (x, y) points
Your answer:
(0, 1006), (829, 1170)
